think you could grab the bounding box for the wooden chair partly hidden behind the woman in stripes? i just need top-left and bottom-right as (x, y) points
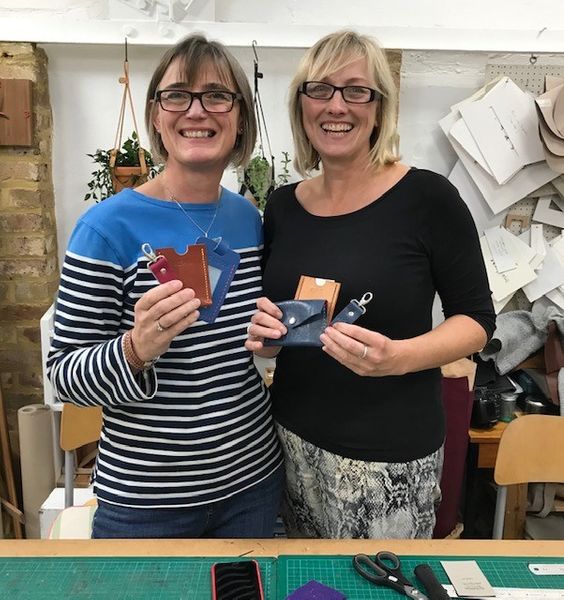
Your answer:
(60, 403), (102, 508)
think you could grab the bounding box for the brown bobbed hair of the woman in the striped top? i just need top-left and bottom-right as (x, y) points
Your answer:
(145, 34), (257, 167)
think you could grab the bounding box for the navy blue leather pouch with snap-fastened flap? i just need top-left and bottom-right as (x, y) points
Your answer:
(264, 300), (327, 348)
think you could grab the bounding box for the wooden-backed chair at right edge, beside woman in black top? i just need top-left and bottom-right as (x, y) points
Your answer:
(493, 415), (564, 539)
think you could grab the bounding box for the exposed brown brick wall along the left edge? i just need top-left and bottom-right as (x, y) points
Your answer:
(0, 42), (59, 472)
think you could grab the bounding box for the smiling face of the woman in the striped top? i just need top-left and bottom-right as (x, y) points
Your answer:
(153, 60), (240, 171)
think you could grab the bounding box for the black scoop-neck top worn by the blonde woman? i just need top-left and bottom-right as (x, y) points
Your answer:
(263, 169), (495, 462)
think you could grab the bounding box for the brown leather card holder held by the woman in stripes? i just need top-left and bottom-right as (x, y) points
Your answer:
(153, 244), (212, 306)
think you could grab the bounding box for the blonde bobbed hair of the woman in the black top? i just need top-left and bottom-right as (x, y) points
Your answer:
(289, 30), (399, 177)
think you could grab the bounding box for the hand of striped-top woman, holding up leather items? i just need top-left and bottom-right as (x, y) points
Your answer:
(131, 279), (200, 361)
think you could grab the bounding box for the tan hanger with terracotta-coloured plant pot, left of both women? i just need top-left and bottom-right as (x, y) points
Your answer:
(110, 38), (148, 193)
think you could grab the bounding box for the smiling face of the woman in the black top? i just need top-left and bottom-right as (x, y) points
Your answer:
(301, 58), (378, 165)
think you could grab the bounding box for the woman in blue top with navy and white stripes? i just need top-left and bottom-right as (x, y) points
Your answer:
(48, 35), (284, 538)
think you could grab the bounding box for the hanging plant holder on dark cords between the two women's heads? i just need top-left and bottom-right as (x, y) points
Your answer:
(239, 40), (276, 202)
